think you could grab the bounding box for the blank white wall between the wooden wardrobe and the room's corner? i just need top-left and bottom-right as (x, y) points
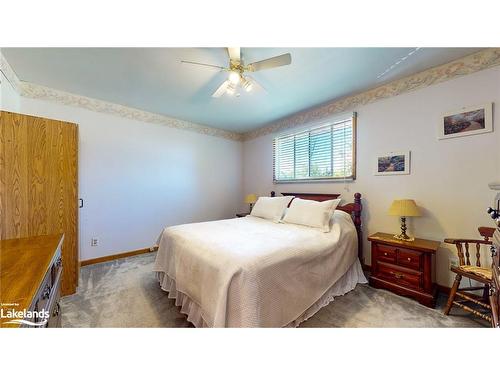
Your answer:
(0, 79), (242, 260)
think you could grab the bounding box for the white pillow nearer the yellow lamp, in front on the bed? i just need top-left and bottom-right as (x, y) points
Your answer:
(281, 198), (340, 233)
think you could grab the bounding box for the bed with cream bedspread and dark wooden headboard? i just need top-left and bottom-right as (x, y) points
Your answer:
(153, 192), (366, 327)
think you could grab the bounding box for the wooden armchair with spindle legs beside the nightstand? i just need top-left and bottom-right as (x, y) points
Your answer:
(444, 227), (495, 322)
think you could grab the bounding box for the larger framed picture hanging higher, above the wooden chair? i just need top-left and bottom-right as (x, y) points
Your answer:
(438, 103), (493, 139)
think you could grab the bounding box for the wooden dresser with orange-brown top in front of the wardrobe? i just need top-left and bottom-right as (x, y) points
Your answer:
(0, 234), (64, 328)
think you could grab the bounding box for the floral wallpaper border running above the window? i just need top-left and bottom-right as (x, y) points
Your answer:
(243, 48), (500, 141)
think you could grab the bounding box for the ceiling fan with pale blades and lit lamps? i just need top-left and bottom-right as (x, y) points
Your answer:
(181, 47), (292, 98)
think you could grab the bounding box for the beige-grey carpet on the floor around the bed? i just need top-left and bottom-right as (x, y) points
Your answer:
(61, 253), (488, 328)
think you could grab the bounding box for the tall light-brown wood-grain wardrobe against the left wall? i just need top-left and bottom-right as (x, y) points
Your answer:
(0, 111), (79, 295)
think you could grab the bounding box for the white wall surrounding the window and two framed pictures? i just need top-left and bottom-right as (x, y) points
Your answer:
(242, 67), (500, 285)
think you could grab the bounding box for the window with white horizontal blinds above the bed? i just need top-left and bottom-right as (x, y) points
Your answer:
(273, 113), (356, 183)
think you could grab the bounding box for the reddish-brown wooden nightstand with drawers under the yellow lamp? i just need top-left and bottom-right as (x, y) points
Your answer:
(368, 232), (440, 307)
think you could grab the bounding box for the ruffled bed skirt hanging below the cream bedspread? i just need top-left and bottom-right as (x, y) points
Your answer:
(157, 259), (368, 328)
